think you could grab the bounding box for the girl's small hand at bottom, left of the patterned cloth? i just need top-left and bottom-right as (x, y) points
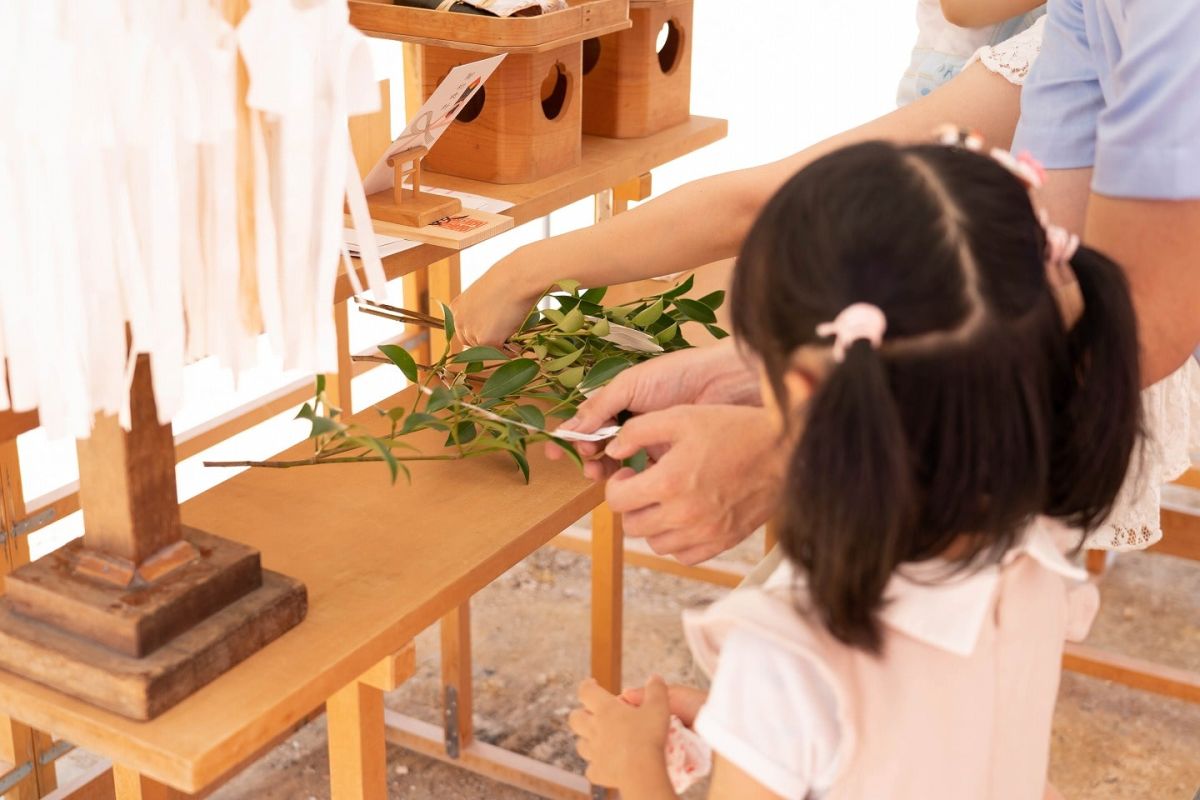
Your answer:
(569, 676), (674, 796)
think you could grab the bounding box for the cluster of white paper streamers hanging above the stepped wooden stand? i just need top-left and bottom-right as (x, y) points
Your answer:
(0, 0), (384, 438)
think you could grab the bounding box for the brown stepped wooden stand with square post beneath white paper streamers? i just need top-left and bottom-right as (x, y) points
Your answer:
(0, 355), (307, 720)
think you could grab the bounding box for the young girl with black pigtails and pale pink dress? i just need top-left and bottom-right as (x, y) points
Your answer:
(571, 143), (1140, 800)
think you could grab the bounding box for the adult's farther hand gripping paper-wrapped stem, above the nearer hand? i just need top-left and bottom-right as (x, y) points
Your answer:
(546, 339), (762, 481)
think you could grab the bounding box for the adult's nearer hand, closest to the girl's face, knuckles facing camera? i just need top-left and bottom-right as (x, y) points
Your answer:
(605, 405), (791, 565)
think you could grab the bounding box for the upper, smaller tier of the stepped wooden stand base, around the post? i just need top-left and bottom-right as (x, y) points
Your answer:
(7, 528), (263, 657)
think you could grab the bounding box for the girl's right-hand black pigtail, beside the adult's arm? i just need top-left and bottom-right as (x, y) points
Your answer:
(1046, 247), (1142, 530)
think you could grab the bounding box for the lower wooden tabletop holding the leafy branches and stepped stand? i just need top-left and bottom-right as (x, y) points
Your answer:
(0, 388), (604, 792)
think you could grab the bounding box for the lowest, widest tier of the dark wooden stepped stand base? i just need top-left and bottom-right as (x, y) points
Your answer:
(0, 571), (308, 720)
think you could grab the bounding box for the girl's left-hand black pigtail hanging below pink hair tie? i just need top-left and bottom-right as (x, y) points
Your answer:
(782, 339), (916, 652)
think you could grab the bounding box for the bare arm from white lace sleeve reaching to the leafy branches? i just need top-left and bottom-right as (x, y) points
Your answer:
(454, 65), (1020, 344)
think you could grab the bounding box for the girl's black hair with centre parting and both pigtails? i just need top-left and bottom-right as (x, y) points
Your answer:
(733, 143), (1141, 651)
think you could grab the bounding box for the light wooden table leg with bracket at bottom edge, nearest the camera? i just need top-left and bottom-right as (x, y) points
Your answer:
(325, 643), (416, 800)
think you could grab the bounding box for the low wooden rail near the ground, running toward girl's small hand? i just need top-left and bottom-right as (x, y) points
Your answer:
(384, 709), (592, 800)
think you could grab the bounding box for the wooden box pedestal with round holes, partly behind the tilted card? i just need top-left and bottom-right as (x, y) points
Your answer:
(421, 42), (583, 184)
